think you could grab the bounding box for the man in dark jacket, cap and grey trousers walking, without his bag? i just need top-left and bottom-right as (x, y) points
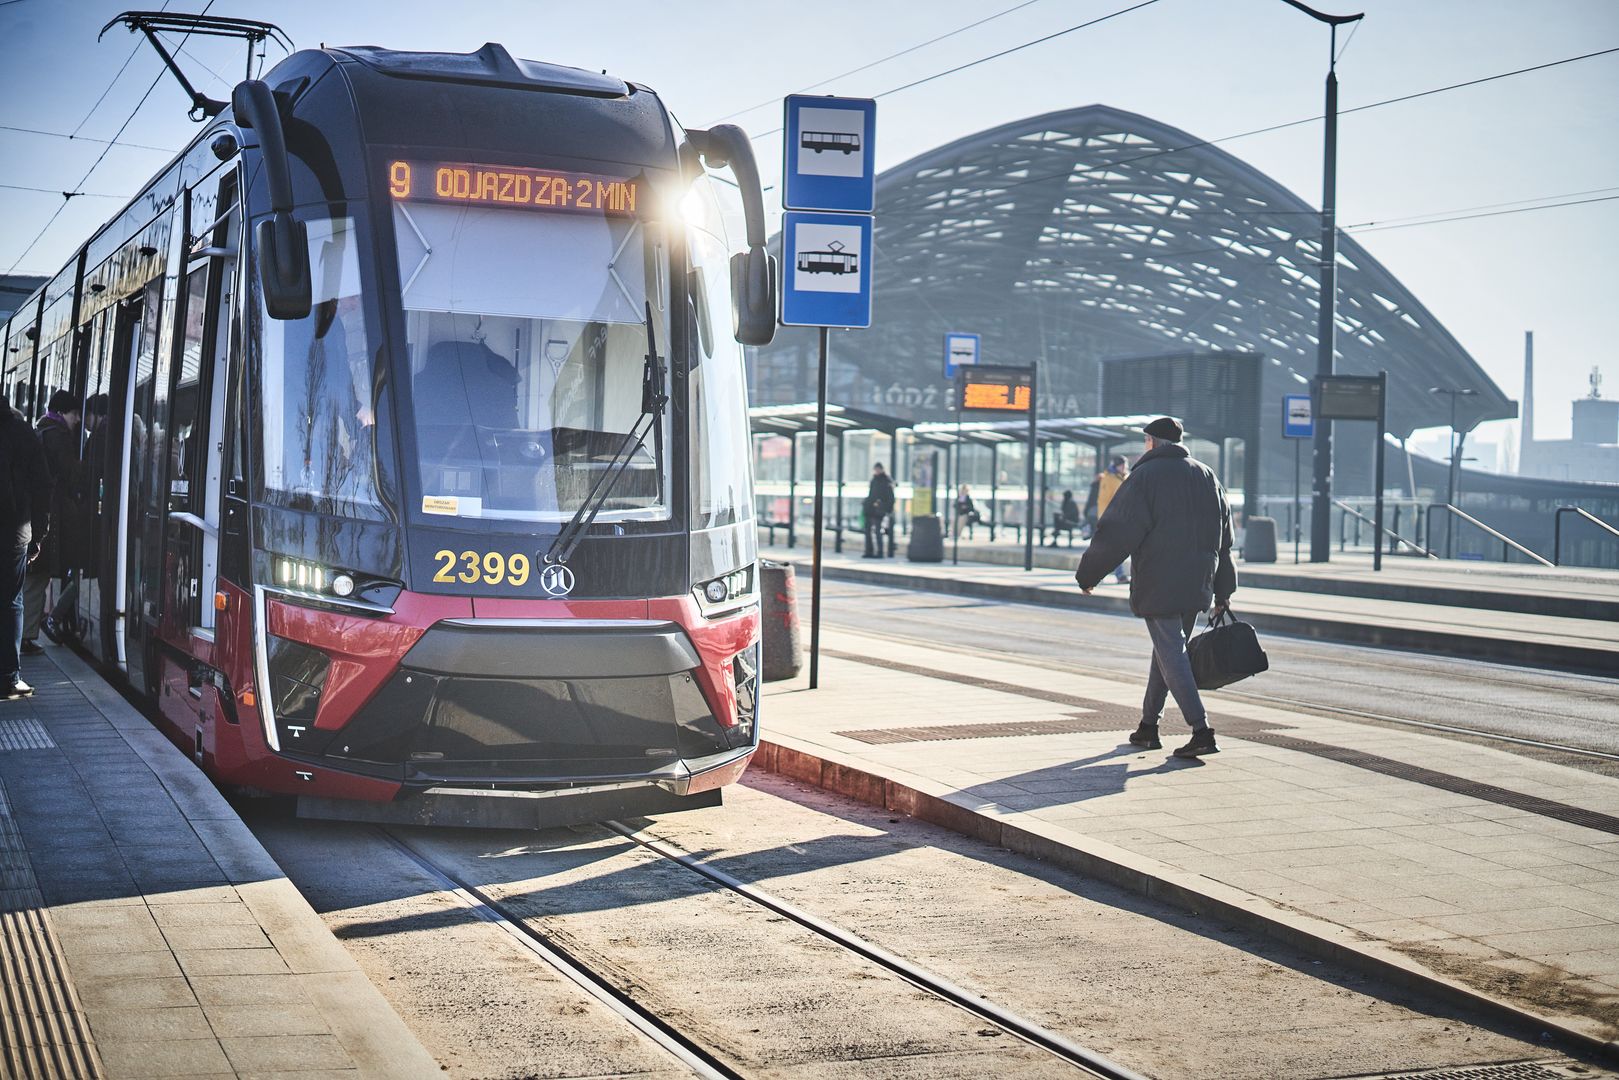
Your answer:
(1073, 416), (1237, 758)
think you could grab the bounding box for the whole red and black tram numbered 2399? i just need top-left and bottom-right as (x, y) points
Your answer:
(3, 33), (776, 824)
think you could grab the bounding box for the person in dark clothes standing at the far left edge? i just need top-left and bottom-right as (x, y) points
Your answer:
(0, 390), (50, 699)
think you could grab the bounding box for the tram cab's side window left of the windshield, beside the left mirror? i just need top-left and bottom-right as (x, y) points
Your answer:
(253, 217), (385, 520)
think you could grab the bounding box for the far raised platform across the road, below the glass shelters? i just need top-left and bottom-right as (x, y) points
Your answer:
(761, 539), (1619, 674)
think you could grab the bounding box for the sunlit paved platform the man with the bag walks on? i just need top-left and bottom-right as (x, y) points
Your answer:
(756, 630), (1619, 1059)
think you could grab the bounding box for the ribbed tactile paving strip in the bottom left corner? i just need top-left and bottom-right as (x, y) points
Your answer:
(0, 784), (104, 1080)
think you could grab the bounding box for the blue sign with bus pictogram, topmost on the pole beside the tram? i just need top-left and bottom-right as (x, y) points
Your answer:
(782, 94), (877, 214)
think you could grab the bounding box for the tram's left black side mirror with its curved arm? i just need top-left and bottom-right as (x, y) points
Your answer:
(230, 79), (311, 319)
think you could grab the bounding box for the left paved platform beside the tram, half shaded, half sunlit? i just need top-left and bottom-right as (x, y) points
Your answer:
(0, 648), (442, 1080)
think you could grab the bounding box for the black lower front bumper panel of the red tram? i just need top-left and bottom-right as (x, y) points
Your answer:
(276, 619), (758, 798)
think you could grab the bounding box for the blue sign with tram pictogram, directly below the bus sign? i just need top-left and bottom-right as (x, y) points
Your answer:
(782, 210), (871, 329)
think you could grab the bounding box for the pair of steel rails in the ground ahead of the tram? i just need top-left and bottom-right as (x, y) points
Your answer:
(376, 821), (1148, 1080)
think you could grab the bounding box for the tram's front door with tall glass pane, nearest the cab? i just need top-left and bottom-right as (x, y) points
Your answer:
(162, 173), (240, 646)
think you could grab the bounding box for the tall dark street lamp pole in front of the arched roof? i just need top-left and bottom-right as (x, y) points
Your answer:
(1282, 0), (1366, 562)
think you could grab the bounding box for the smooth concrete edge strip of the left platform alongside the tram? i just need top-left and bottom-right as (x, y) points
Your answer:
(50, 649), (444, 1080)
